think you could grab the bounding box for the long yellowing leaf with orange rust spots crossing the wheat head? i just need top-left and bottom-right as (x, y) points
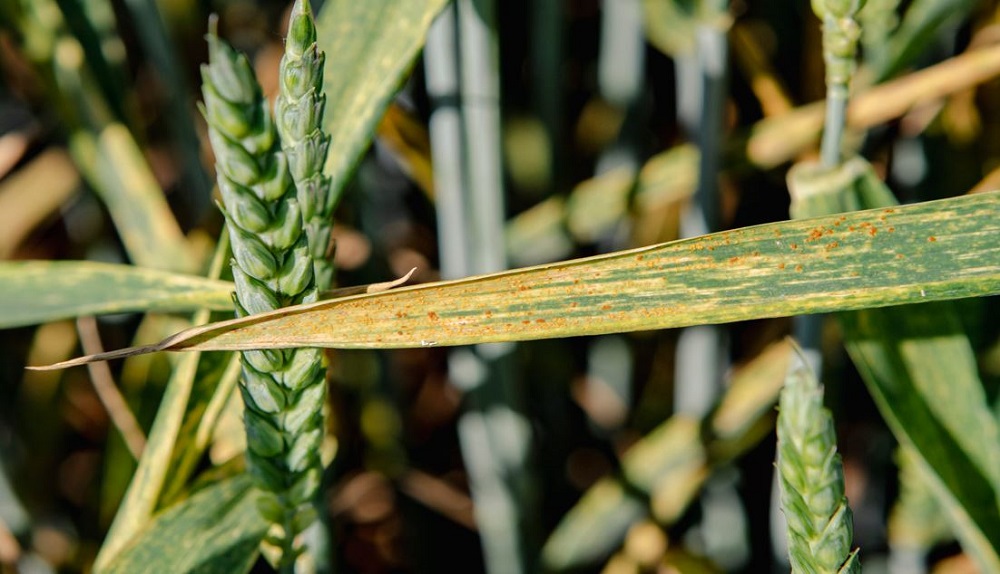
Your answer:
(35, 192), (1000, 368)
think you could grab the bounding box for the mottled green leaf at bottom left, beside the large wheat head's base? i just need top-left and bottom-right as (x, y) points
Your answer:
(100, 474), (268, 574)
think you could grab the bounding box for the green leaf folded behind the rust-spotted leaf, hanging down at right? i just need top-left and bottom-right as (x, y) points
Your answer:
(789, 158), (1000, 572)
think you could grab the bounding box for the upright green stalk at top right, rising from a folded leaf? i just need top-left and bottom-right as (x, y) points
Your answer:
(812, 0), (865, 168)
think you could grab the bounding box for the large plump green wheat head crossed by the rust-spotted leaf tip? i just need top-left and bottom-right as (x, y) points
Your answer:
(202, 19), (326, 572)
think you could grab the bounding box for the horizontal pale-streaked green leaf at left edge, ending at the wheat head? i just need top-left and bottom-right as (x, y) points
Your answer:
(0, 261), (233, 329)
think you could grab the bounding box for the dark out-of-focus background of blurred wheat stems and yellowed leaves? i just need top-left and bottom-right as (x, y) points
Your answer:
(0, 0), (1000, 574)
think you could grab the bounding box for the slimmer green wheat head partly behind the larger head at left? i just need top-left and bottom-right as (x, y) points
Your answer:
(274, 0), (336, 291)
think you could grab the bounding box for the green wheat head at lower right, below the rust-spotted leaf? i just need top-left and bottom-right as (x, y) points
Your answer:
(777, 352), (861, 574)
